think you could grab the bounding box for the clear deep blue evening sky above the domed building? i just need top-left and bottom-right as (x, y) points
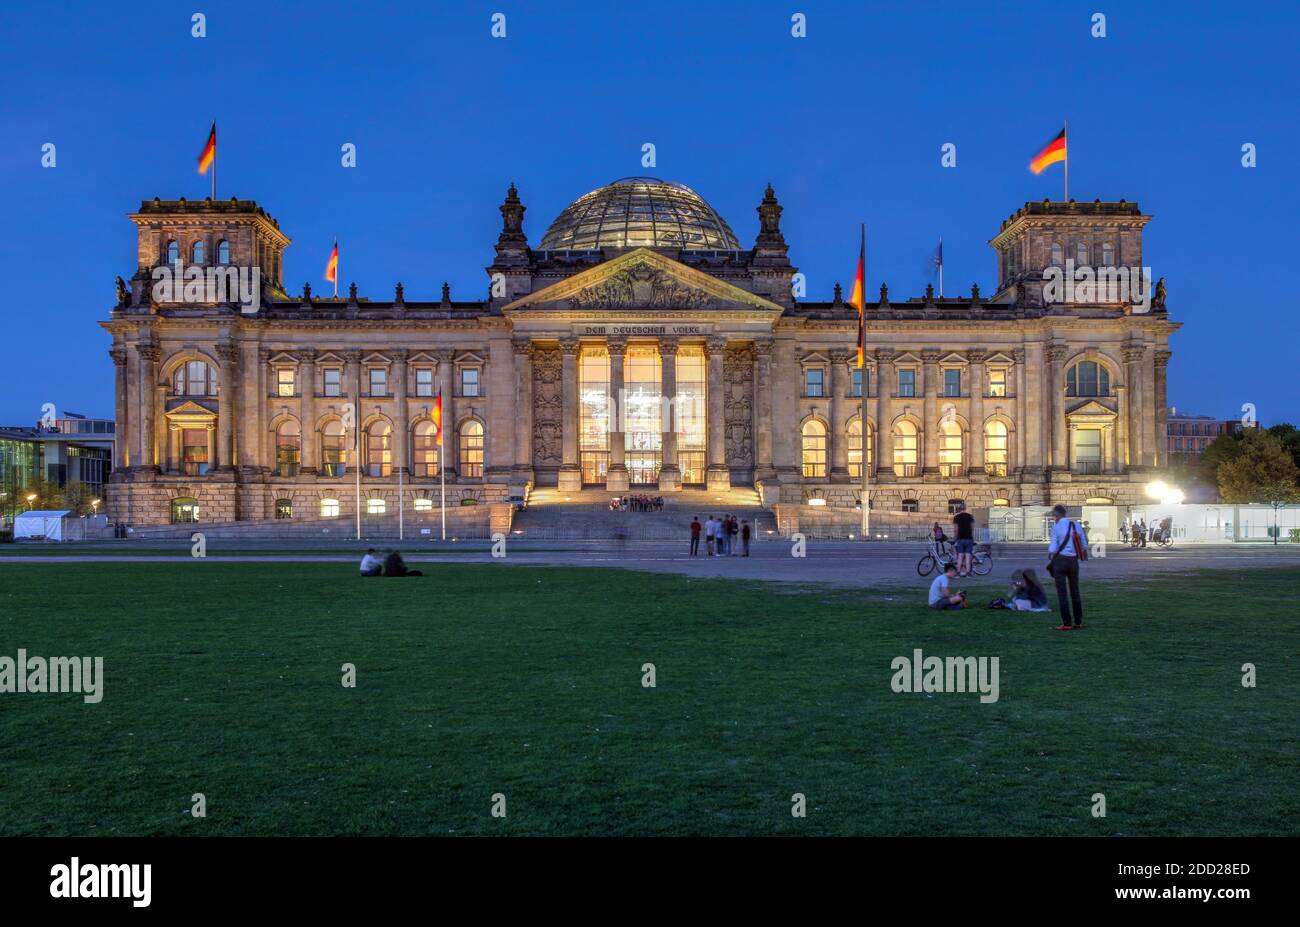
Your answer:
(0, 0), (1300, 424)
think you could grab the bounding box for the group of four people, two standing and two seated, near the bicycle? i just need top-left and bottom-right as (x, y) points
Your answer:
(928, 506), (1088, 631)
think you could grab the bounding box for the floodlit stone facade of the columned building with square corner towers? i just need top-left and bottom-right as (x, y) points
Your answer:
(103, 184), (1178, 525)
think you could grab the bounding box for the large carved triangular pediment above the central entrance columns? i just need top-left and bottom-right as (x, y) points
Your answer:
(504, 248), (783, 313)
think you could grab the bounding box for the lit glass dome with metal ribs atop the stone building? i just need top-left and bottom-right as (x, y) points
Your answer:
(538, 177), (741, 251)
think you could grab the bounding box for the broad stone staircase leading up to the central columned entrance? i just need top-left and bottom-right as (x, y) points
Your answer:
(512, 488), (776, 541)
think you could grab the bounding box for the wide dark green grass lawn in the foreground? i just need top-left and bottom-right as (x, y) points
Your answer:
(0, 563), (1300, 835)
